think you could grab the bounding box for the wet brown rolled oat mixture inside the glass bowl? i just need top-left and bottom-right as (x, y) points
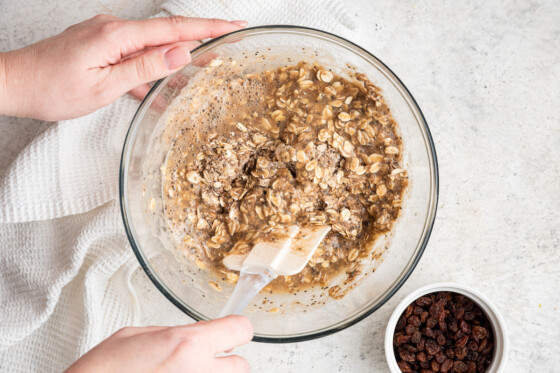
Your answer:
(163, 60), (408, 297)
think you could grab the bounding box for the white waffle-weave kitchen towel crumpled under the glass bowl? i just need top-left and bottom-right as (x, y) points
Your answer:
(0, 0), (356, 372)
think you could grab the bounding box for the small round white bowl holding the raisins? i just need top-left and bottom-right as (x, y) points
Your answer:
(385, 282), (508, 373)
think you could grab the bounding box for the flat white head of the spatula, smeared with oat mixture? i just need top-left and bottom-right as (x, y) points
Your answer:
(223, 225), (331, 276)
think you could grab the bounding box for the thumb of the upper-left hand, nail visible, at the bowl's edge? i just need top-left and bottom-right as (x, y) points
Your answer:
(110, 45), (191, 92)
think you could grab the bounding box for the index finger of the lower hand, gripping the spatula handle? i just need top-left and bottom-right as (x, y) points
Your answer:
(191, 315), (253, 353)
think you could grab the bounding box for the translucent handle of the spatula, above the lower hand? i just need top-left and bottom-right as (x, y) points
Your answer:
(218, 268), (274, 317)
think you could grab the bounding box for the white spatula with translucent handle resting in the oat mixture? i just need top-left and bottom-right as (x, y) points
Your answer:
(219, 225), (331, 317)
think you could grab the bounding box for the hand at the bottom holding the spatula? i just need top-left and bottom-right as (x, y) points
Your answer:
(66, 316), (253, 373)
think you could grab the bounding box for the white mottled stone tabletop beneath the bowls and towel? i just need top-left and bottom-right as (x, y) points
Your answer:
(0, 0), (560, 373)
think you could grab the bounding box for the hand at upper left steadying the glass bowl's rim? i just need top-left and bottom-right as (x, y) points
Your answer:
(0, 15), (247, 121)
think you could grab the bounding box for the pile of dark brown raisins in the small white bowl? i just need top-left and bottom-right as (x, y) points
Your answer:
(393, 292), (494, 373)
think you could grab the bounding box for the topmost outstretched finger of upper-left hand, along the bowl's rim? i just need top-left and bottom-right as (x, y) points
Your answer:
(114, 16), (247, 56)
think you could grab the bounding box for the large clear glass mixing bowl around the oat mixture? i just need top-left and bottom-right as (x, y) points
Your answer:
(119, 26), (438, 342)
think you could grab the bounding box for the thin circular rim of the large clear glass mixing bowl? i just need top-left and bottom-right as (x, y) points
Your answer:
(119, 24), (439, 343)
